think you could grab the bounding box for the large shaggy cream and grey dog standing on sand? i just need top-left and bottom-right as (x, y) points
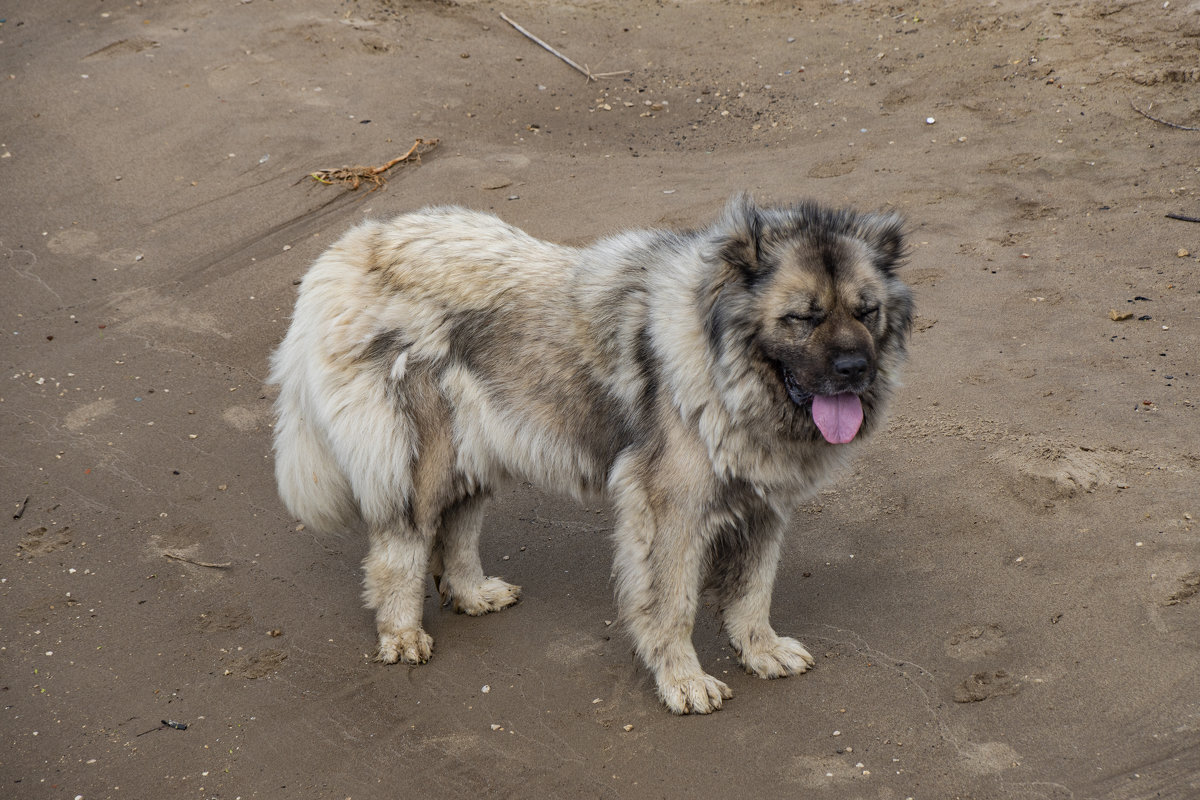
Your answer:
(271, 196), (912, 714)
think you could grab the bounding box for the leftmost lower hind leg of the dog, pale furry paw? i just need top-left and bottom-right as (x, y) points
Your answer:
(362, 523), (433, 664)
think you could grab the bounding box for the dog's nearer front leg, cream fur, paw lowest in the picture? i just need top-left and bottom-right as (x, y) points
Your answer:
(616, 492), (733, 714)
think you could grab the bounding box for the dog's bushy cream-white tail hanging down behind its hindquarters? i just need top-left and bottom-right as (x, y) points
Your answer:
(270, 321), (361, 533)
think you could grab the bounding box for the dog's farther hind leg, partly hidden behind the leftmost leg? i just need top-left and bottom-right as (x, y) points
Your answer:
(434, 493), (521, 616)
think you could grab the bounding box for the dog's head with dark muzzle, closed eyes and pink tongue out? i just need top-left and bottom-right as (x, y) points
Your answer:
(716, 196), (912, 444)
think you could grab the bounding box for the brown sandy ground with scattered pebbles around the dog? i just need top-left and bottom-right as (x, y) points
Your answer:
(0, 0), (1200, 800)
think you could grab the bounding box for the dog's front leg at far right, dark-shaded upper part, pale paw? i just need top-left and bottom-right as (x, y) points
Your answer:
(712, 521), (814, 678)
